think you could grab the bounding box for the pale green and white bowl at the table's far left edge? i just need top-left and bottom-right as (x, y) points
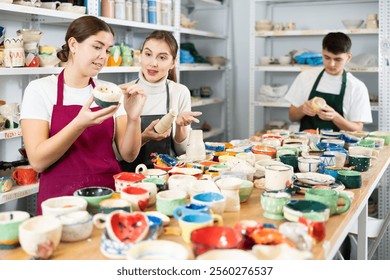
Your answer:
(0, 211), (30, 250)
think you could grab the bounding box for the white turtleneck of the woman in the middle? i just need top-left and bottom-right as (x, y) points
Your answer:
(123, 72), (191, 155)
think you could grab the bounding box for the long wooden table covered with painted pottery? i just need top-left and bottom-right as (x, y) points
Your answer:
(0, 147), (390, 260)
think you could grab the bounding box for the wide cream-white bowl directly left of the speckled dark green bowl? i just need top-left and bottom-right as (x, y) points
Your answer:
(41, 196), (88, 216)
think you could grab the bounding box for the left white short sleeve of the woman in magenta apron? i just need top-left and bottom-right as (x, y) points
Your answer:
(20, 81), (53, 122)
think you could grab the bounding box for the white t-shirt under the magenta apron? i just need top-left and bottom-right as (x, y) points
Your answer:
(20, 75), (126, 126)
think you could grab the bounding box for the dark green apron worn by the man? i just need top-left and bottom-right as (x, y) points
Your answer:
(299, 69), (347, 131)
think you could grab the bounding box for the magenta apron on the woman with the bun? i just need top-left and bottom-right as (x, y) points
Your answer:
(37, 71), (121, 215)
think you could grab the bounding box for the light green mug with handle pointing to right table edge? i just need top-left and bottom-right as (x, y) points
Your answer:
(305, 189), (351, 215)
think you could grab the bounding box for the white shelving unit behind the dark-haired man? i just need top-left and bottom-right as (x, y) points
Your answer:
(249, 0), (379, 135)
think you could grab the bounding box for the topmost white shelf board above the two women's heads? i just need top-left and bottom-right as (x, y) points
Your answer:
(0, 3), (174, 32)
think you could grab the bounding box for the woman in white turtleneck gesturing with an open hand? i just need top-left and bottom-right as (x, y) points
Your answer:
(121, 30), (202, 171)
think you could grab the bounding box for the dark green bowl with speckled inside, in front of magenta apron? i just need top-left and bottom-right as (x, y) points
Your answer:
(73, 187), (114, 214)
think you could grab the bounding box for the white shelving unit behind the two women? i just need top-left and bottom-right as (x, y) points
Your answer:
(0, 0), (232, 211)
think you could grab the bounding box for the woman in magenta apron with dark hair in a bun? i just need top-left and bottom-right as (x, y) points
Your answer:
(21, 16), (146, 214)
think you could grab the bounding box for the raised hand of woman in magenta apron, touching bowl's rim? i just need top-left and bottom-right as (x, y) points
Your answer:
(120, 84), (147, 120)
